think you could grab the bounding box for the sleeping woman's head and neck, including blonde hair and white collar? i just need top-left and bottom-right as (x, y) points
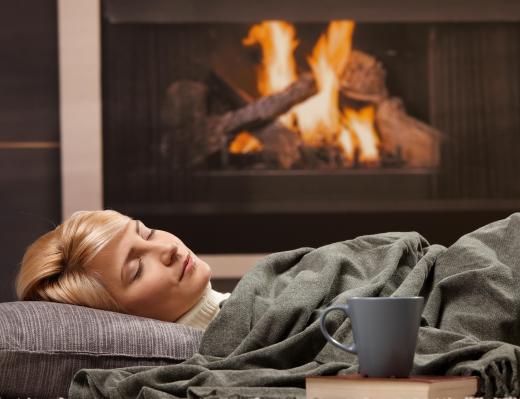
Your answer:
(16, 210), (229, 329)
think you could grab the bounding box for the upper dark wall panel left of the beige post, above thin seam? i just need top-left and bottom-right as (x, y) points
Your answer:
(0, 0), (59, 141)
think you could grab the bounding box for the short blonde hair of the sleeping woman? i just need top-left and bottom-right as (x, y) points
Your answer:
(16, 210), (130, 312)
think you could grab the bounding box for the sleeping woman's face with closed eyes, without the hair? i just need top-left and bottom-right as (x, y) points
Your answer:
(86, 220), (211, 321)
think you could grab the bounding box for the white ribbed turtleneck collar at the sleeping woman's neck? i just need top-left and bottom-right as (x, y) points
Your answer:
(176, 282), (231, 330)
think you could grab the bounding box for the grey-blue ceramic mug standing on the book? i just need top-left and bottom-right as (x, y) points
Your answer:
(320, 296), (424, 377)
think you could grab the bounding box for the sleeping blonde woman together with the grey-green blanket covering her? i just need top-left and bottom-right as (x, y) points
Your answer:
(16, 210), (520, 398)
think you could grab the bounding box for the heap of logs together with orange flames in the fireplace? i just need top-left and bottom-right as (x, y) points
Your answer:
(189, 20), (442, 170)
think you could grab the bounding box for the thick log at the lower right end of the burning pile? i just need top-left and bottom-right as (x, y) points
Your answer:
(376, 98), (443, 168)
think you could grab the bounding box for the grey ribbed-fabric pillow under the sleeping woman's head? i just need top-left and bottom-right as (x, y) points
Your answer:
(0, 301), (203, 398)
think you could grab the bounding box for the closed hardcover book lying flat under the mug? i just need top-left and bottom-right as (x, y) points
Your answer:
(305, 374), (478, 399)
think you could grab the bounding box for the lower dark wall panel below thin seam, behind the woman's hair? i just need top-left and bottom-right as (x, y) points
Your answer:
(0, 149), (61, 302)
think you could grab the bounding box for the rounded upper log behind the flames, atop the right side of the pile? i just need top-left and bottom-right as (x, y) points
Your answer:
(340, 50), (388, 103)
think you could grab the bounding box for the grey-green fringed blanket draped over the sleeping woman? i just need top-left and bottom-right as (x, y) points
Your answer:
(69, 213), (520, 399)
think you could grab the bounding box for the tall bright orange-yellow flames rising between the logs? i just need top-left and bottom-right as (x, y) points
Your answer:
(243, 21), (379, 164)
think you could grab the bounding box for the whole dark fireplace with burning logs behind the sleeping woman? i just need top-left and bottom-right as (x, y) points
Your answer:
(102, 1), (520, 252)
